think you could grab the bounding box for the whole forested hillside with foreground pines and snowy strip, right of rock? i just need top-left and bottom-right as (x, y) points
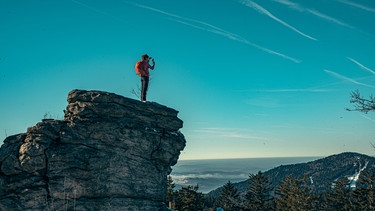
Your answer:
(166, 152), (375, 211)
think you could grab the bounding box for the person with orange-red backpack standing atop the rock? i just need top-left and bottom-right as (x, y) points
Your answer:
(135, 54), (155, 102)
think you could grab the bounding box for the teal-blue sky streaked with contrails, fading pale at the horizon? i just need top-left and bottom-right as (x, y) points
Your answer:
(0, 0), (375, 159)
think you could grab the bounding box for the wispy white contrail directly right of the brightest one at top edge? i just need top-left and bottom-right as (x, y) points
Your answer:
(274, 0), (353, 28)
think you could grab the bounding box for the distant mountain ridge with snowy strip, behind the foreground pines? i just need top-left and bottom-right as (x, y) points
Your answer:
(208, 152), (375, 196)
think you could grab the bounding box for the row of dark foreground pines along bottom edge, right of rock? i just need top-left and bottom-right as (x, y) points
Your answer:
(166, 169), (375, 211)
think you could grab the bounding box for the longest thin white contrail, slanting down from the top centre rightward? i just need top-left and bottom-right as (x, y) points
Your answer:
(126, 2), (301, 63)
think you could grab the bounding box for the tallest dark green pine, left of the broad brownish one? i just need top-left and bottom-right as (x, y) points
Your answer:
(245, 171), (274, 211)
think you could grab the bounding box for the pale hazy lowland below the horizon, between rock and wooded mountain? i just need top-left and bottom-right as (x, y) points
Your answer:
(170, 157), (320, 193)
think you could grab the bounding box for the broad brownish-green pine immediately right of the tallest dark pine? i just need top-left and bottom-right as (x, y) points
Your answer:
(275, 176), (314, 211)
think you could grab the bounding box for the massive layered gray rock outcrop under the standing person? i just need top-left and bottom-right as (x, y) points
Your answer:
(0, 90), (186, 210)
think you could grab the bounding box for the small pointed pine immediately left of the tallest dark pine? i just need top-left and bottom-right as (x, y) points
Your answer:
(217, 181), (240, 211)
